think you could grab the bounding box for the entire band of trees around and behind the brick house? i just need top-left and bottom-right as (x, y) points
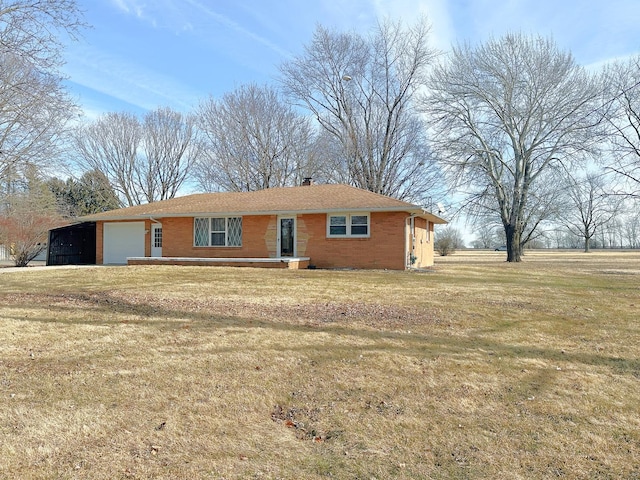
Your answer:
(0, 0), (640, 262)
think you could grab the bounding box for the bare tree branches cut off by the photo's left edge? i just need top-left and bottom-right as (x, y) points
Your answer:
(0, 0), (83, 194)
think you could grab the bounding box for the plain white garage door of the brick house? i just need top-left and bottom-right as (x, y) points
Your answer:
(103, 222), (144, 264)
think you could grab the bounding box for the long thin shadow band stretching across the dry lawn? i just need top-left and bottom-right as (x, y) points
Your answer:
(5, 294), (640, 378)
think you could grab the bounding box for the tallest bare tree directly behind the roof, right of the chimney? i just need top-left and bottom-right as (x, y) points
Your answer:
(280, 19), (439, 200)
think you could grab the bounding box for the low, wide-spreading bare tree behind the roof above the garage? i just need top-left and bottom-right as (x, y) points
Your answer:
(75, 108), (200, 206)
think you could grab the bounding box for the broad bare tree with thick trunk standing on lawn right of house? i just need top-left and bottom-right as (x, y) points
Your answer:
(424, 34), (602, 262)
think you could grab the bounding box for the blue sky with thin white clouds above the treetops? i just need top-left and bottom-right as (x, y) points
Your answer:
(63, 0), (640, 119)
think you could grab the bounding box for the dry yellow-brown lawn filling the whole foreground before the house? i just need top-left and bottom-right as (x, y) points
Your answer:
(0, 252), (640, 479)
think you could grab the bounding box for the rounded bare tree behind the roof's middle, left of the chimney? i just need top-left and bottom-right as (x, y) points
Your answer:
(196, 84), (316, 191)
